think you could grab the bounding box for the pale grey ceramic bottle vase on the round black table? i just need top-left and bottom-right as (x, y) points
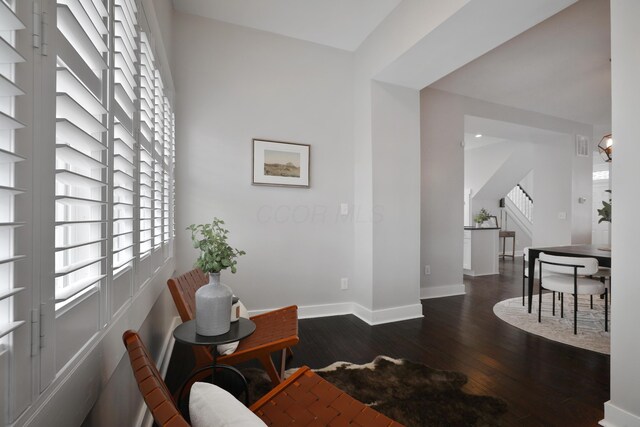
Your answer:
(196, 273), (232, 336)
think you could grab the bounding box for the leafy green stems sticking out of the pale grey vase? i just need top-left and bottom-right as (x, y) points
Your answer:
(187, 218), (246, 273)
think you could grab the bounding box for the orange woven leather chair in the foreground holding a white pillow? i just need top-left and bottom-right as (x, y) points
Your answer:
(122, 331), (402, 427)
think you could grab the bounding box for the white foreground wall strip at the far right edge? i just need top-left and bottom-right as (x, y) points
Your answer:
(603, 0), (640, 426)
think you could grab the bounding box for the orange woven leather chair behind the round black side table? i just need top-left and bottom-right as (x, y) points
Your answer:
(167, 268), (299, 386)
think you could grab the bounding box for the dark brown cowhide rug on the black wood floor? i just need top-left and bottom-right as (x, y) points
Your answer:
(242, 356), (507, 427)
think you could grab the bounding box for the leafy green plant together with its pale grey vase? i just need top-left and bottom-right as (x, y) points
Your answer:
(187, 218), (245, 336)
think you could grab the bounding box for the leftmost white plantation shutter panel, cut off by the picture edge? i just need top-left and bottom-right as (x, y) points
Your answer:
(0, 1), (32, 425)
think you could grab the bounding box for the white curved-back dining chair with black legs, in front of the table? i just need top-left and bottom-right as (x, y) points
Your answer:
(538, 252), (609, 334)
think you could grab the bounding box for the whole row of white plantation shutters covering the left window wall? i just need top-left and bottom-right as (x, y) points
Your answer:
(0, 0), (175, 425)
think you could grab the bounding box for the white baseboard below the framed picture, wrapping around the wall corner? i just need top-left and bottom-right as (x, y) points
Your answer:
(249, 302), (422, 325)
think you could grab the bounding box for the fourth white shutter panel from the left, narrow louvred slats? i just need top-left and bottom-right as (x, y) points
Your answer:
(138, 32), (155, 259)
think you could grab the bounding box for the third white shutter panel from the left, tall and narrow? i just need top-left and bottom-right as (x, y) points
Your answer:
(113, 0), (138, 275)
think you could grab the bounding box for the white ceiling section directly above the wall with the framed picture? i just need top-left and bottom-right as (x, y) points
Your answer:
(173, 0), (401, 51)
